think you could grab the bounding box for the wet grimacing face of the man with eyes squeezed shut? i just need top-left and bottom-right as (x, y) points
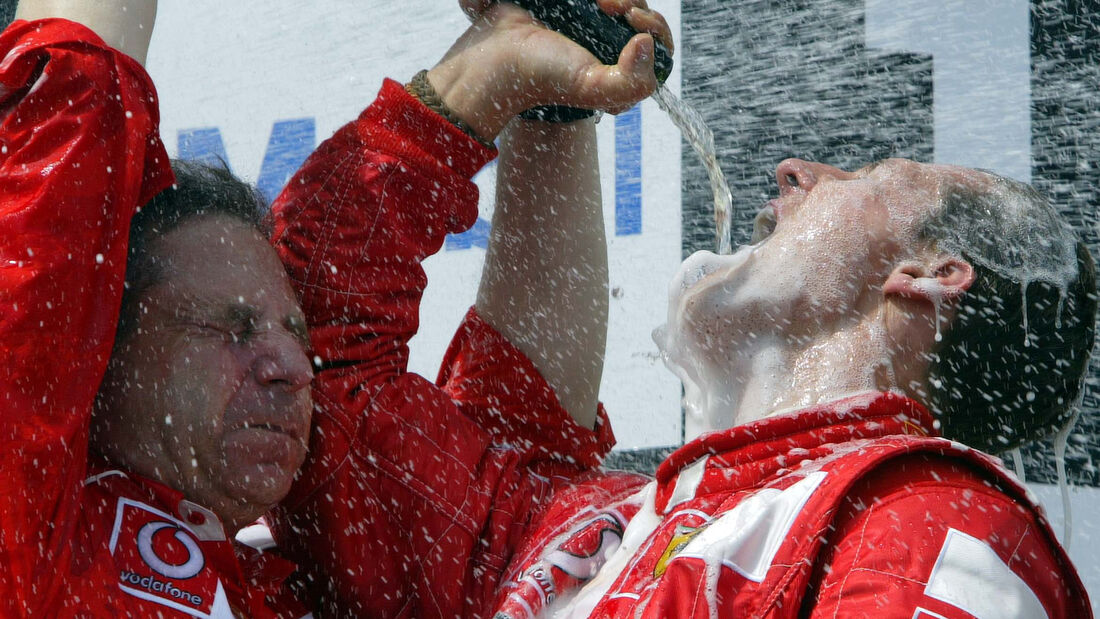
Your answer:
(92, 215), (312, 527)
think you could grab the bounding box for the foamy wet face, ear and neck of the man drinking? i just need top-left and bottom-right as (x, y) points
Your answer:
(657, 159), (988, 431)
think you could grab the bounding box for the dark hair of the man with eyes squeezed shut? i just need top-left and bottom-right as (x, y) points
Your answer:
(116, 159), (267, 340)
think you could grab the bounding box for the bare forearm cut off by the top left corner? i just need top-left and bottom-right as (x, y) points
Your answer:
(15, 0), (156, 65)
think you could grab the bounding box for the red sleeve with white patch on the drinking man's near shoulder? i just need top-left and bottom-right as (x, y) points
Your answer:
(804, 456), (1092, 619)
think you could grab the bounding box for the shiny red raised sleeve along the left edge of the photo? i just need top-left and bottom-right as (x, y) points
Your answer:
(0, 20), (172, 616)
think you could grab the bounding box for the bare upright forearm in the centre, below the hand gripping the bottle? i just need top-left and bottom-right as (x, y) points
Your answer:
(477, 121), (607, 428)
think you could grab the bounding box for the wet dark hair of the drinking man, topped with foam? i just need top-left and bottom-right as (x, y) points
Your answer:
(923, 175), (1097, 453)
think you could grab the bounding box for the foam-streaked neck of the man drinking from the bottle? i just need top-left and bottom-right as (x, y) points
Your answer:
(684, 318), (898, 439)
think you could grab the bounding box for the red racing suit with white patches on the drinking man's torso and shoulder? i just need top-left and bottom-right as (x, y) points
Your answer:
(496, 394), (1092, 619)
